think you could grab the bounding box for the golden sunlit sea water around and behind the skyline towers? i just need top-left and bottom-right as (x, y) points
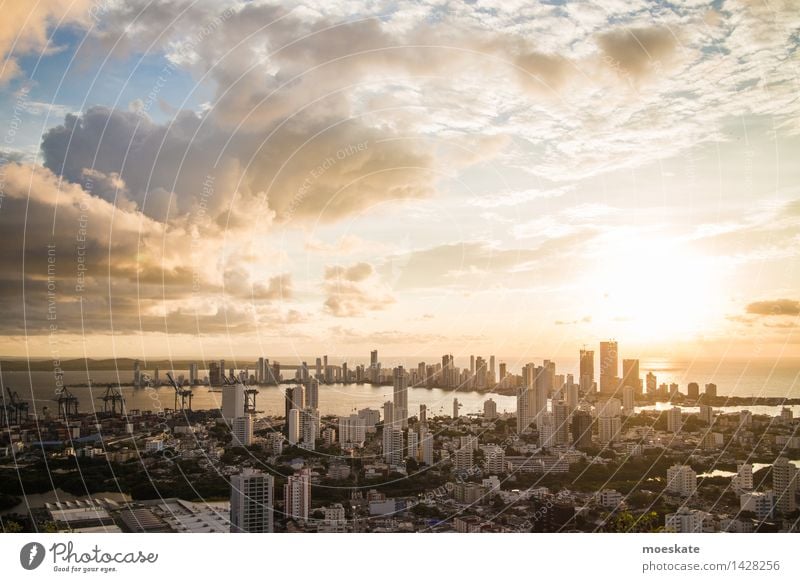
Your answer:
(0, 359), (800, 416)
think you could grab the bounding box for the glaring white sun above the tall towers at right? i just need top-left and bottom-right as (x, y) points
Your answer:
(590, 238), (723, 343)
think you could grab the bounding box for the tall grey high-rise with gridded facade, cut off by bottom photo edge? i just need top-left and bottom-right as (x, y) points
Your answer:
(231, 468), (275, 533)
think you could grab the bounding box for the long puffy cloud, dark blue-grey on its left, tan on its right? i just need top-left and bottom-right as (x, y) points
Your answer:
(42, 107), (433, 226)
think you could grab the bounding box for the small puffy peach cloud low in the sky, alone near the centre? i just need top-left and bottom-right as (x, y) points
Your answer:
(323, 263), (395, 317)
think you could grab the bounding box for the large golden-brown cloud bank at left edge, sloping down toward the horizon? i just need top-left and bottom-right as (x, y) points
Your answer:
(0, 163), (303, 336)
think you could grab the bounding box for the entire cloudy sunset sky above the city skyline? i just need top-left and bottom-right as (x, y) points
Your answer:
(0, 0), (800, 359)
